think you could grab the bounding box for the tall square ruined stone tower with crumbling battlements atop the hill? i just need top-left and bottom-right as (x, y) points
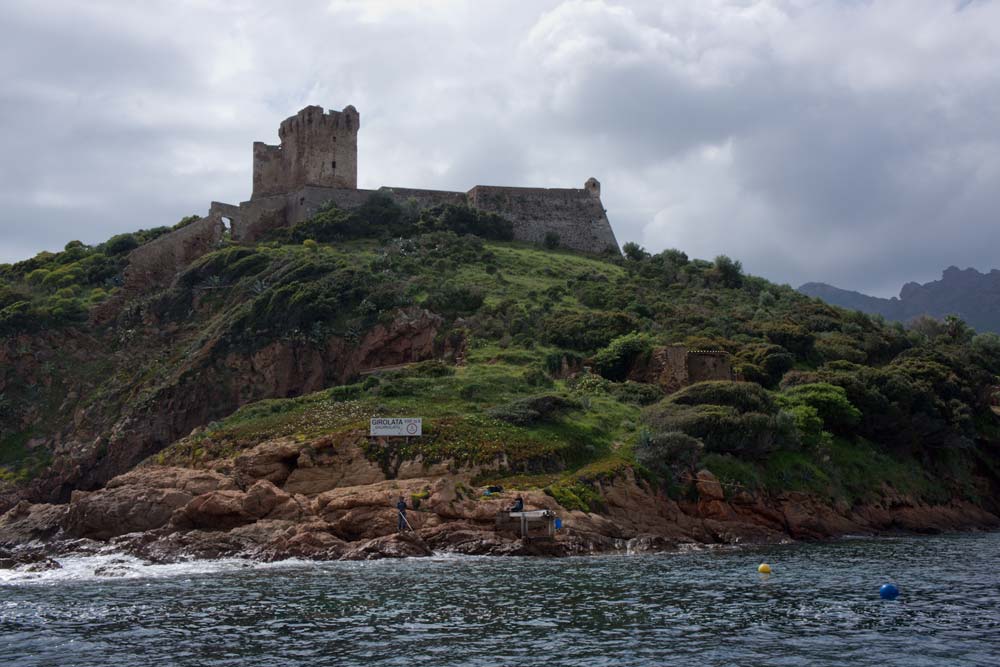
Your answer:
(250, 106), (361, 199)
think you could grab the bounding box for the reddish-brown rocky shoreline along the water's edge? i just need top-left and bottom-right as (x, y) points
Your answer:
(0, 441), (1000, 569)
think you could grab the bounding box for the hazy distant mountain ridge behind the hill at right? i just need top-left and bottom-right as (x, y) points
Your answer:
(799, 266), (1000, 333)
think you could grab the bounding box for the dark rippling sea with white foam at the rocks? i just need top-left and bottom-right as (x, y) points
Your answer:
(0, 533), (1000, 667)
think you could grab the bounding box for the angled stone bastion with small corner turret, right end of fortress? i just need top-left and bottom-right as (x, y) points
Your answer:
(468, 179), (618, 253)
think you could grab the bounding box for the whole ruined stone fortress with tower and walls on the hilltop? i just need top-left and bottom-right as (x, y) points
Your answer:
(210, 106), (619, 253)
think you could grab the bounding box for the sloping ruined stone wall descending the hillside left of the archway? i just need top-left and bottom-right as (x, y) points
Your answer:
(124, 214), (225, 292)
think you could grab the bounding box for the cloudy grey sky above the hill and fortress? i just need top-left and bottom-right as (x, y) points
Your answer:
(0, 0), (1000, 296)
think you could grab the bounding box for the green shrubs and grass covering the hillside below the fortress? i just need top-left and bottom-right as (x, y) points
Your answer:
(0, 194), (1000, 509)
